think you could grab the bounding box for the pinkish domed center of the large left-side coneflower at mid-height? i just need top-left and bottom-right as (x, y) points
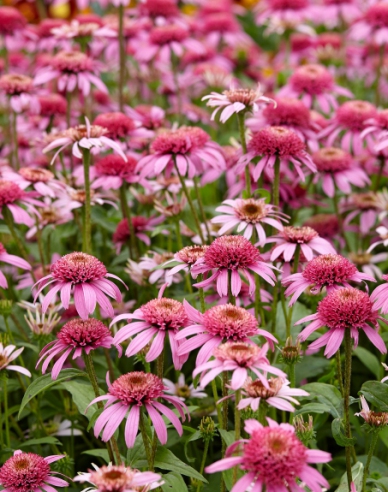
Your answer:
(50, 252), (107, 284)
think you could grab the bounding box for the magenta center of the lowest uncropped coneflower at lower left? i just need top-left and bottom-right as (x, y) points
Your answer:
(109, 371), (164, 406)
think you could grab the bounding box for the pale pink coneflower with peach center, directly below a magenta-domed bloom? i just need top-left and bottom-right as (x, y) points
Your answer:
(193, 342), (286, 391)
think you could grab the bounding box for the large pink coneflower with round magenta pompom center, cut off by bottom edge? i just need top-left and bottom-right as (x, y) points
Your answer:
(205, 417), (331, 492)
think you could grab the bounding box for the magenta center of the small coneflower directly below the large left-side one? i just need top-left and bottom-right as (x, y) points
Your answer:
(57, 318), (111, 349)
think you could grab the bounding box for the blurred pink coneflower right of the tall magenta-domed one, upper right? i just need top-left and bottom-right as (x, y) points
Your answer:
(313, 147), (370, 198)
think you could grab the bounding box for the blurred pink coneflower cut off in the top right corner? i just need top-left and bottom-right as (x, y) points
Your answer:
(349, 1), (388, 46)
